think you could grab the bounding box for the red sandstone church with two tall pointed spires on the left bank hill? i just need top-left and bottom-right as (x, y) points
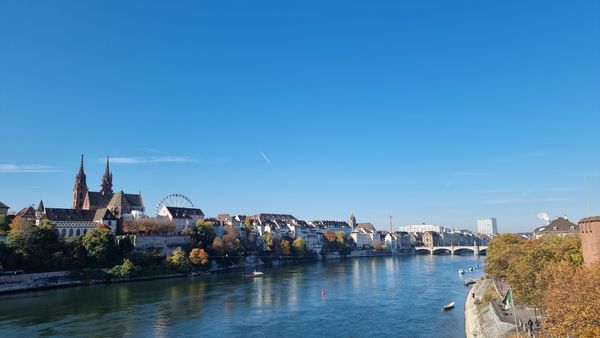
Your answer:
(73, 155), (144, 219)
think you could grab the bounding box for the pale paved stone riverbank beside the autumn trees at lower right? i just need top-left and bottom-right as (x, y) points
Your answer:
(465, 279), (515, 338)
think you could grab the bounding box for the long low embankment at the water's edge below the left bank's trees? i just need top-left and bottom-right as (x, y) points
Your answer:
(0, 250), (393, 295)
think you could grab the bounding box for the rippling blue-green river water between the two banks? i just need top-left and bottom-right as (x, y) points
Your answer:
(0, 256), (483, 337)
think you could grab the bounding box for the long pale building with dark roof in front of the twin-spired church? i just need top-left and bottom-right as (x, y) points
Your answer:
(35, 201), (119, 238)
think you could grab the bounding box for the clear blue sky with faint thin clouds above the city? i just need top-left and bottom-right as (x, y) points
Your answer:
(0, 0), (600, 231)
